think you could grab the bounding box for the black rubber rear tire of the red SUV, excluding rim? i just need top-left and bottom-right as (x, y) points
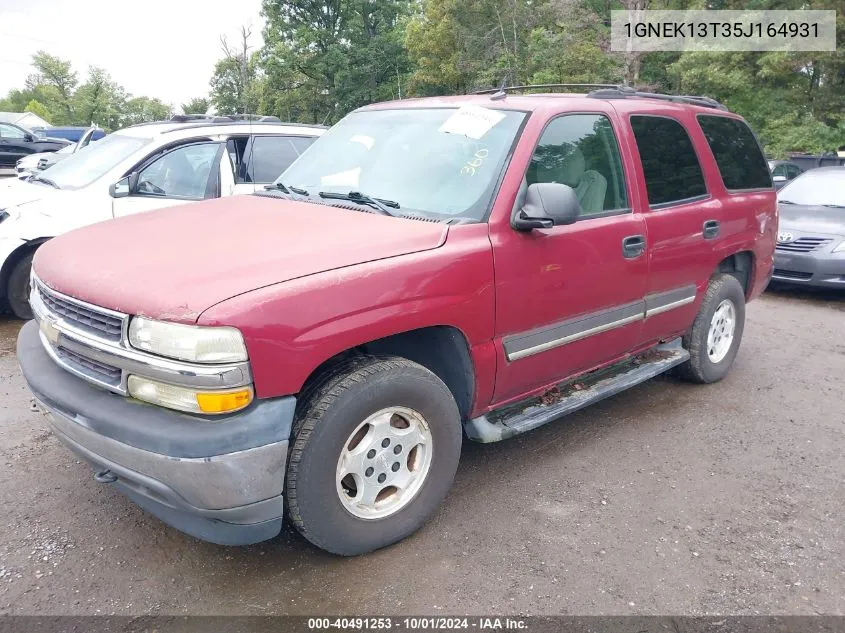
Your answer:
(676, 274), (745, 383)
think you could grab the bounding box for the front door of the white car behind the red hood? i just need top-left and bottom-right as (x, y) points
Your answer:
(112, 141), (234, 217)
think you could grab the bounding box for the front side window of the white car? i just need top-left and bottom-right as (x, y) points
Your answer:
(136, 143), (220, 200)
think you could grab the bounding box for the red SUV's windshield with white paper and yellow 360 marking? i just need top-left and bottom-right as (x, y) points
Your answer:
(278, 107), (525, 220)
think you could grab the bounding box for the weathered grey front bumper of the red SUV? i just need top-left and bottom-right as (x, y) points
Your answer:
(17, 321), (296, 545)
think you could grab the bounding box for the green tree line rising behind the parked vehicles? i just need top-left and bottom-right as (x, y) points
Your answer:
(0, 0), (845, 156)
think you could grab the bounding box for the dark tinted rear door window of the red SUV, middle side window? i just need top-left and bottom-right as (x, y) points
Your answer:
(631, 115), (707, 207)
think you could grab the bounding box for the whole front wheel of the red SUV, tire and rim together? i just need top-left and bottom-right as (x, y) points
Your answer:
(285, 356), (462, 556)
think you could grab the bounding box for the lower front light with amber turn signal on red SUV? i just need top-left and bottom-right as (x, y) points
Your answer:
(127, 376), (253, 414)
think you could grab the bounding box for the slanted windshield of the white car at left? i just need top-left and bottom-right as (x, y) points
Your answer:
(42, 134), (151, 189)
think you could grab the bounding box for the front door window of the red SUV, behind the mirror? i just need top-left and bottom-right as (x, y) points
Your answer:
(525, 114), (628, 218)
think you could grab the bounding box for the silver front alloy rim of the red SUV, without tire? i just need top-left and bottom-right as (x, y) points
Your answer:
(335, 407), (433, 519)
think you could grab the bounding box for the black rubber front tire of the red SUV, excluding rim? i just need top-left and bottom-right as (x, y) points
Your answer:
(285, 356), (462, 556)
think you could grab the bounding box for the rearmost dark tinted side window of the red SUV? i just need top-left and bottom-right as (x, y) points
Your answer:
(698, 114), (772, 190)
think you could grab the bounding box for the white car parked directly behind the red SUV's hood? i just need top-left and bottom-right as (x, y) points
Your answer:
(0, 117), (325, 319)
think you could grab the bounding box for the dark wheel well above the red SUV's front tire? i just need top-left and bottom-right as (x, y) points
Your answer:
(300, 325), (475, 419)
